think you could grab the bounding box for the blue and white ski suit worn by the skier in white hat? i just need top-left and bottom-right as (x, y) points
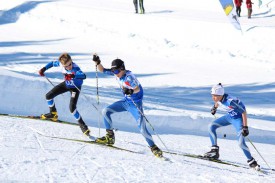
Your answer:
(208, 94), (252, 160)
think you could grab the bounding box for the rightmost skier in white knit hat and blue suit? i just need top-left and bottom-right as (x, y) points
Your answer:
(204, 83), (260, 169)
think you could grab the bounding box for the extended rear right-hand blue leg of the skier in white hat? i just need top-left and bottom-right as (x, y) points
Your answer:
(231, 118), (252, 160)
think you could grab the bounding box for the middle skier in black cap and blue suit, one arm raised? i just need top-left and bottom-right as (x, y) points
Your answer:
(93, 54), (162, 157)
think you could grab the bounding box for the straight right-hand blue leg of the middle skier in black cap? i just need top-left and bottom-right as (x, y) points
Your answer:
(127, 102), (155, 147)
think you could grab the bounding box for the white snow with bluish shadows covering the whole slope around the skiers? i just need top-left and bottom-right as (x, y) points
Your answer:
(0, 0), (275, 182)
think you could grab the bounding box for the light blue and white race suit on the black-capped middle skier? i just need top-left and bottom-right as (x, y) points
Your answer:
(102, 69), (155, 147)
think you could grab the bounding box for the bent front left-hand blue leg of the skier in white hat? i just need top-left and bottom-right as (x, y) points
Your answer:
(208, 115), (230, 146)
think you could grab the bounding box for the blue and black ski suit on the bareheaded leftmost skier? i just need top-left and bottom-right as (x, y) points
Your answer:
(45, 61), (86, 124)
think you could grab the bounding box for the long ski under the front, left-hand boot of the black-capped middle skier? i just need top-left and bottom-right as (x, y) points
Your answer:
(29, 127), (142, 154)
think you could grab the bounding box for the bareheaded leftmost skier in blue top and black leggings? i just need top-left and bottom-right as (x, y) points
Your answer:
(39, 53), (90, 136)
